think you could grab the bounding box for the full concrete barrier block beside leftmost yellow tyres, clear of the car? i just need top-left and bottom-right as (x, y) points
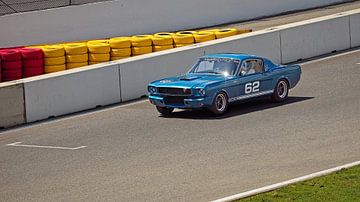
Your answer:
(24, 63), (121, 122)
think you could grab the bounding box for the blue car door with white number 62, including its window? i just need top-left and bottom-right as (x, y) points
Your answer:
(230, 58), (272, 101)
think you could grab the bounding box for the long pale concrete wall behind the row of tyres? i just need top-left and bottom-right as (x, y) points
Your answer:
(0, 0), (347, 47)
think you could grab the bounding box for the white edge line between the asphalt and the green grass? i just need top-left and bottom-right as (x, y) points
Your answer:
(212, 161), (360, 202)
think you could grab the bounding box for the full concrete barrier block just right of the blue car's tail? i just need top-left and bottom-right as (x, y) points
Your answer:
(280, 16), (350, 63)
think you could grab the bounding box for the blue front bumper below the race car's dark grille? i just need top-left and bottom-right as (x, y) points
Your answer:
(149, 95), (206, 109)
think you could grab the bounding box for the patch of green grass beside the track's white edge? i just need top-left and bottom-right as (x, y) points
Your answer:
(238, 166), (360, 202)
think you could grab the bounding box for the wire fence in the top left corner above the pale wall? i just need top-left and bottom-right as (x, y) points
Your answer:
(0, 0), (109, 16)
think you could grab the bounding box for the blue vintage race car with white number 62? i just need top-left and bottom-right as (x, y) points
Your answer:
(148, 53), (301, 115)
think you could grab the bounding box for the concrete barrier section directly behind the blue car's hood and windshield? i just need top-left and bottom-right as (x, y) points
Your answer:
(119, 45), (204, 101)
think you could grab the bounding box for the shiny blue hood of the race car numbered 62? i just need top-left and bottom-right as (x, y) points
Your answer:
(150, 74), (225, 88)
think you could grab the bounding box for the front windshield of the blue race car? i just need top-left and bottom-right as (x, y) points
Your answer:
(191, 58), (240, 76)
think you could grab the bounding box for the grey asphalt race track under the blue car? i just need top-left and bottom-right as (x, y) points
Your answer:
(0, 48), (360, 201)
